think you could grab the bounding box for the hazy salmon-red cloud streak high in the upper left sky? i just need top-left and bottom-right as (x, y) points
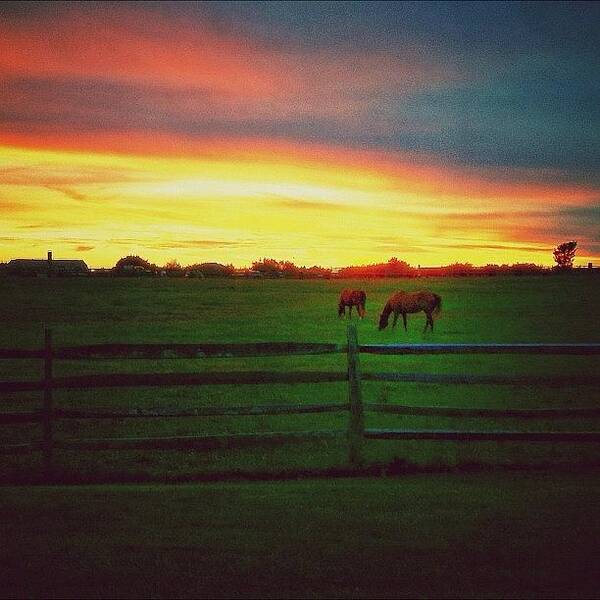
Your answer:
(0, 4), (454, 127)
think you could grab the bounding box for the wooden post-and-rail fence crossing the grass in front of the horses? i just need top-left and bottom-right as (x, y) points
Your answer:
(0, 324), (600, 480)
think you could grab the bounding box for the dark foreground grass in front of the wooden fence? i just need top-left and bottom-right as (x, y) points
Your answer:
(0, 473), (600, 598)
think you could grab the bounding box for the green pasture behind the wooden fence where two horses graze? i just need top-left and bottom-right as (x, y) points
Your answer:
(0, 275), (600, 480)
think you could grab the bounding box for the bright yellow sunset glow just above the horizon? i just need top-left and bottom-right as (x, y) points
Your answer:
(0, 147), (596, 267)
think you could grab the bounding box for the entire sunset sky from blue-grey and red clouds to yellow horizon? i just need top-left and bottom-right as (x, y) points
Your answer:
(0, 2), (600, 267)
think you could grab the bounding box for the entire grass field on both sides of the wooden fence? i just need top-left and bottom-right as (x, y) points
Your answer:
(0, 277), (600, 598)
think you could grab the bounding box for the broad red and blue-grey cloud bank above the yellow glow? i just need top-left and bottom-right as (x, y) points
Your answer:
(0, 3), (600, 184)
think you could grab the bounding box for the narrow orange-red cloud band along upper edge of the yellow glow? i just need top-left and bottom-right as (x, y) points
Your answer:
(0, 126), (600, 211)
